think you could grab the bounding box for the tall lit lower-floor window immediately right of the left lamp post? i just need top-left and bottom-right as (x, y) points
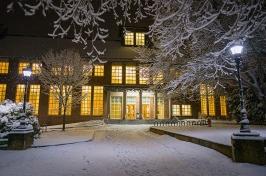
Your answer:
(29, 85), (40, 115)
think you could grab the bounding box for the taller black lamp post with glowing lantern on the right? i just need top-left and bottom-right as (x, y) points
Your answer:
(230, 45), (250, 133)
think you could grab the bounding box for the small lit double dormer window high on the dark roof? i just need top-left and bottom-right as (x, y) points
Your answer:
(124, 32), (145, 46)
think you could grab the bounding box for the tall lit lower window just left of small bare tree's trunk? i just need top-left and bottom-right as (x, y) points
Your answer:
(48, 86), (59, 115)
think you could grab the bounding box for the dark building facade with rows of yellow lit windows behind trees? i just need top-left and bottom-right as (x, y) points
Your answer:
(0, 31), (228, 125)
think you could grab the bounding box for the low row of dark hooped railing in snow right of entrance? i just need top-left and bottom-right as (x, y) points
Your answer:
(153, 118), (210, 126)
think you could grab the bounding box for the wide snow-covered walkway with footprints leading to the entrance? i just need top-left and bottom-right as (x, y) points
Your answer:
(0, 125), (266, 176)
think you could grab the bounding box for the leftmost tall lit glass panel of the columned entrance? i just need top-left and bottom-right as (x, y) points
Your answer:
(110, 96), (122, 119)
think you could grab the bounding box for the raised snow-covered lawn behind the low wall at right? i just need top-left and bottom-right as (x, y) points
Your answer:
(152, 124), (266, 145)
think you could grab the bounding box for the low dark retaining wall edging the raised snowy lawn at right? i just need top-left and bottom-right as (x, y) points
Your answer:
(150, 127), (232, 158)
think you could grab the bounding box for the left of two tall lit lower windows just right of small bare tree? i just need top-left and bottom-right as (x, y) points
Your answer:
(80, 86), (91, 115)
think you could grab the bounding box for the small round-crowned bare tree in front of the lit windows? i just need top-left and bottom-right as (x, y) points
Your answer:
(39, 50), (92, 131)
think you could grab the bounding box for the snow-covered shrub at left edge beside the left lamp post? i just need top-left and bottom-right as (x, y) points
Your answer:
(0, 100), (40, 137)
